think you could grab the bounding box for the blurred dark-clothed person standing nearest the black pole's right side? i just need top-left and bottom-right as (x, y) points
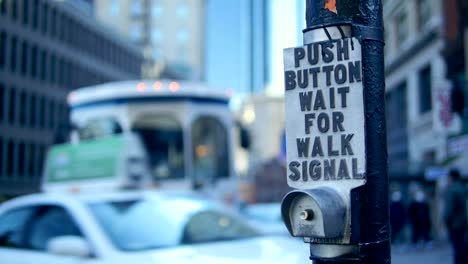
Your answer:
(390, 191), (406, 243)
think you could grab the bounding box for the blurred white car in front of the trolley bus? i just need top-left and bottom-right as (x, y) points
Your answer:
(0, 192), (309, 264)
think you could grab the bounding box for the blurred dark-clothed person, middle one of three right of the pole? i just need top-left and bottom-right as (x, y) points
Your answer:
(408, 190), (431, 246)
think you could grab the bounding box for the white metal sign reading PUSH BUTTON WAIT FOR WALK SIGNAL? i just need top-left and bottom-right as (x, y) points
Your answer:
(284, 38), (366, 189)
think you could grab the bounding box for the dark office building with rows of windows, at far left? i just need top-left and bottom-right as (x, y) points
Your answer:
(0, 0), (143, 195)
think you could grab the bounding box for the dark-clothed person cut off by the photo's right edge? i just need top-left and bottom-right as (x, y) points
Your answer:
(443, 169), (468, 264)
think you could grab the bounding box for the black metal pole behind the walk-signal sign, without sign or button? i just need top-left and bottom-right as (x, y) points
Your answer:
(306, 0), (390, 264)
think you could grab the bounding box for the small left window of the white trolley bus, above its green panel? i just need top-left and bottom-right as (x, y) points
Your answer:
(78, 117), (122, 140)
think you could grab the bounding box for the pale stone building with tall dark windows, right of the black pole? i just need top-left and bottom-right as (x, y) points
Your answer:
(384, 0), (450, 179)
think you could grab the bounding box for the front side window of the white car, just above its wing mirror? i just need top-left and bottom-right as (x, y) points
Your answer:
(26, 206), (82, 251)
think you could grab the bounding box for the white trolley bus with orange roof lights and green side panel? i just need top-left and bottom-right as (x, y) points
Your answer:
(43, 80), (245, 202)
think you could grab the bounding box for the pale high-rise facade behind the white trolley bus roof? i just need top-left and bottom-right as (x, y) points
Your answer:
(94, 0), (205, 80)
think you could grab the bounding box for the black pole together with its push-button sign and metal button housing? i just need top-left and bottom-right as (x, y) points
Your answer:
(282, 0), (390, 264)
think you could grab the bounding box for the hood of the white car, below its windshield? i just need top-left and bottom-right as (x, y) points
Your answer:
(120, 236), (309, 264)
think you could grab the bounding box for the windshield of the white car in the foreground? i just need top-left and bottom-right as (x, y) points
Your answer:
(89, 199), (259, 251)
